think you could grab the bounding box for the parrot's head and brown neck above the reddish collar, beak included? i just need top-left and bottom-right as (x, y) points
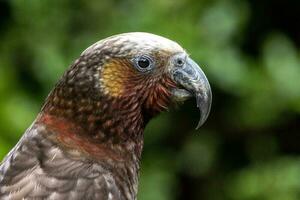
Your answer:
(42, 32), (212, 158)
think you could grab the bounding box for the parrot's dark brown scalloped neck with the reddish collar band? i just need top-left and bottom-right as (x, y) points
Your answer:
(37, 87), (145, 160)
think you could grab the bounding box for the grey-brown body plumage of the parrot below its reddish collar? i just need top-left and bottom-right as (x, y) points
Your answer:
(0, 124), (138, 200)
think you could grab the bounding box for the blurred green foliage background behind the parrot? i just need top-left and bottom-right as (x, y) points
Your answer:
(0, 0), (300, 200)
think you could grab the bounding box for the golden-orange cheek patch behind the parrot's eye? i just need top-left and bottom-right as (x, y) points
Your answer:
(100, 60), (131, 97)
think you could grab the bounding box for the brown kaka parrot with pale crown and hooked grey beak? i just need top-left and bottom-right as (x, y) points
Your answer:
(0, 32), (211, 200)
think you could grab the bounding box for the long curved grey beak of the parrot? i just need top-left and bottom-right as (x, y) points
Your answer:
(171, 55), (212, 129)
